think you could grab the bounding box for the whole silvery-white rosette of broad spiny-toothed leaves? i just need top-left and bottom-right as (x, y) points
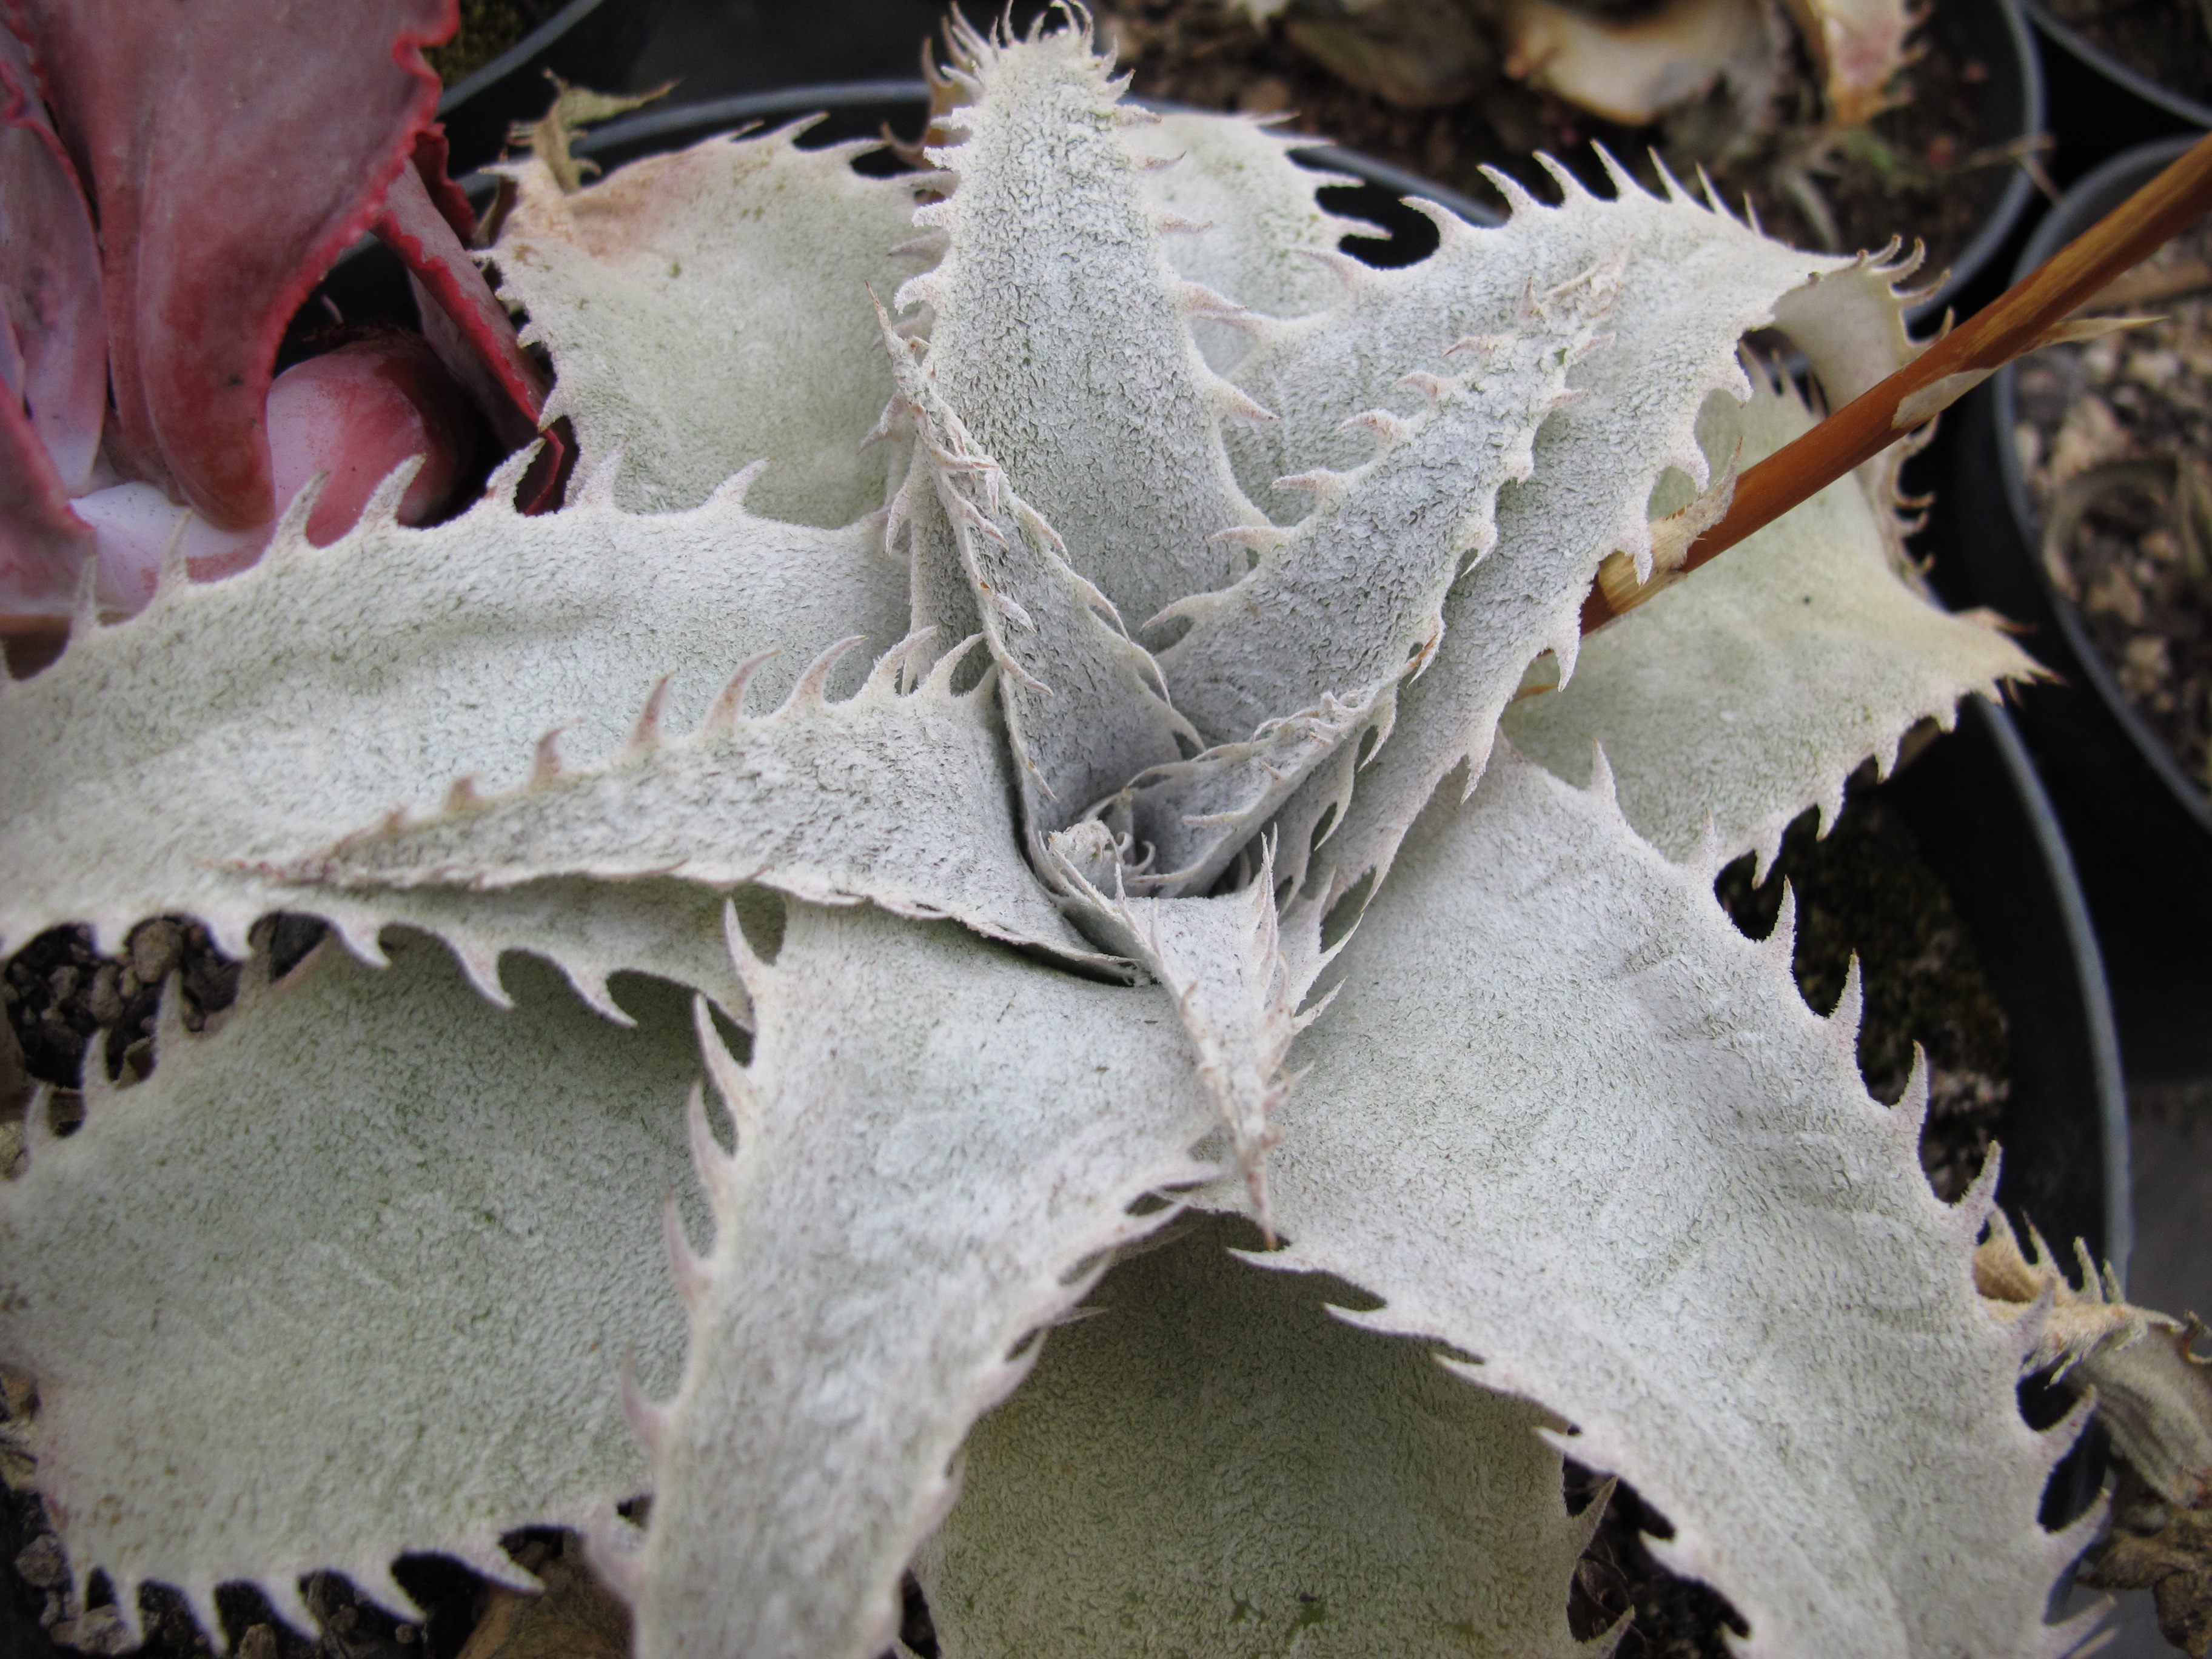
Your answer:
(0, 13), (2123, 1659)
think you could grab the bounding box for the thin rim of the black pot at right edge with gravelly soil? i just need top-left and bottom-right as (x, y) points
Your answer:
(1991, 135), (2212, 836)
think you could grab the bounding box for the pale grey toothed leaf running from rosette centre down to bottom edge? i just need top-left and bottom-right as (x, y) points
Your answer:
(602, 905), (1212, 1659)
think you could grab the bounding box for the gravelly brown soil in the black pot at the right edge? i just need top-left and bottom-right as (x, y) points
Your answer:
(2013, 230), (2212, 788)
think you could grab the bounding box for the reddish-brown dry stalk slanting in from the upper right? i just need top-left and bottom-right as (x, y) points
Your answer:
(1581, 137), (2212, 632)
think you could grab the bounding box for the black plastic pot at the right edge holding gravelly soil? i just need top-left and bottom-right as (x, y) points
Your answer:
(1933, 137), (2212, 925)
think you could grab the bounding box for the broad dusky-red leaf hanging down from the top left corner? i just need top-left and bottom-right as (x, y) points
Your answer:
(16, 0), (455, 529)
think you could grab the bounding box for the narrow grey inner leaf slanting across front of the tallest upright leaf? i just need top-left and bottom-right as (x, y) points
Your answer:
(885, 318), (1199, 843)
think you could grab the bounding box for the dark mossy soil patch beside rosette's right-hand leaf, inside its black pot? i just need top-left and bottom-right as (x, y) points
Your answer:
(1717, 776), (2011, 1201)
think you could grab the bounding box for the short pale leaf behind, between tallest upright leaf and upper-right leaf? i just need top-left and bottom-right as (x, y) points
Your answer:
(1137, 110), (1369, 369)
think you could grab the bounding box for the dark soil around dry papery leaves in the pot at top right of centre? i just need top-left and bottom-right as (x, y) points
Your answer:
(1099, 0), (2011, 272)
